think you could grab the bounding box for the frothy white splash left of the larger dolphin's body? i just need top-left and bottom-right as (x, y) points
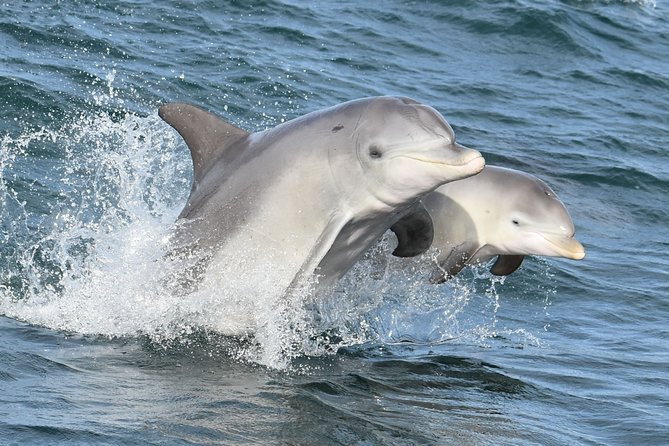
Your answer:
(0, 108), (189, 336)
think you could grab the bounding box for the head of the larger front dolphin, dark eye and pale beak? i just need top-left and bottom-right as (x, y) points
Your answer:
(342, 97), (484, 206)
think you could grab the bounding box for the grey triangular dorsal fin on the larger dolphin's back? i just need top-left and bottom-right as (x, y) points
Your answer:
(158, 103), (249, 188)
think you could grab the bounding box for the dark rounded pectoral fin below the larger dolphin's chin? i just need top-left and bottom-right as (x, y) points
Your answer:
(390, 204), (434, 257)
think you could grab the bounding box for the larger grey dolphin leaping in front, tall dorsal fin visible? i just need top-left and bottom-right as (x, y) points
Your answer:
(159, 97), (484, 293)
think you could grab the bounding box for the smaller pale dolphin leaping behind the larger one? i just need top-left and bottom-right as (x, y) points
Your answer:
(391, 166), (585, 283)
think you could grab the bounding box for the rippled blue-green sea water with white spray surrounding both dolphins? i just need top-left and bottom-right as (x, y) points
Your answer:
(0, 0), (669, 445)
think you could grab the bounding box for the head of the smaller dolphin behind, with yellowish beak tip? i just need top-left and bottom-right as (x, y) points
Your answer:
(470, 167), (585, 260)
